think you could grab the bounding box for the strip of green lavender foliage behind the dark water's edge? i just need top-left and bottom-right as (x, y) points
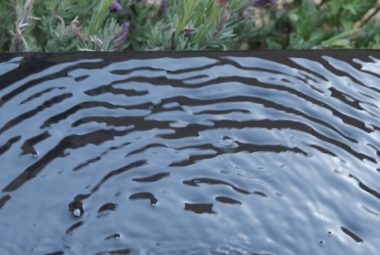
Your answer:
(0, 0), (380, 52)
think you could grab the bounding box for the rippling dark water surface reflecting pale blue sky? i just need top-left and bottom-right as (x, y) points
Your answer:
(0, 51), (380, 255)
